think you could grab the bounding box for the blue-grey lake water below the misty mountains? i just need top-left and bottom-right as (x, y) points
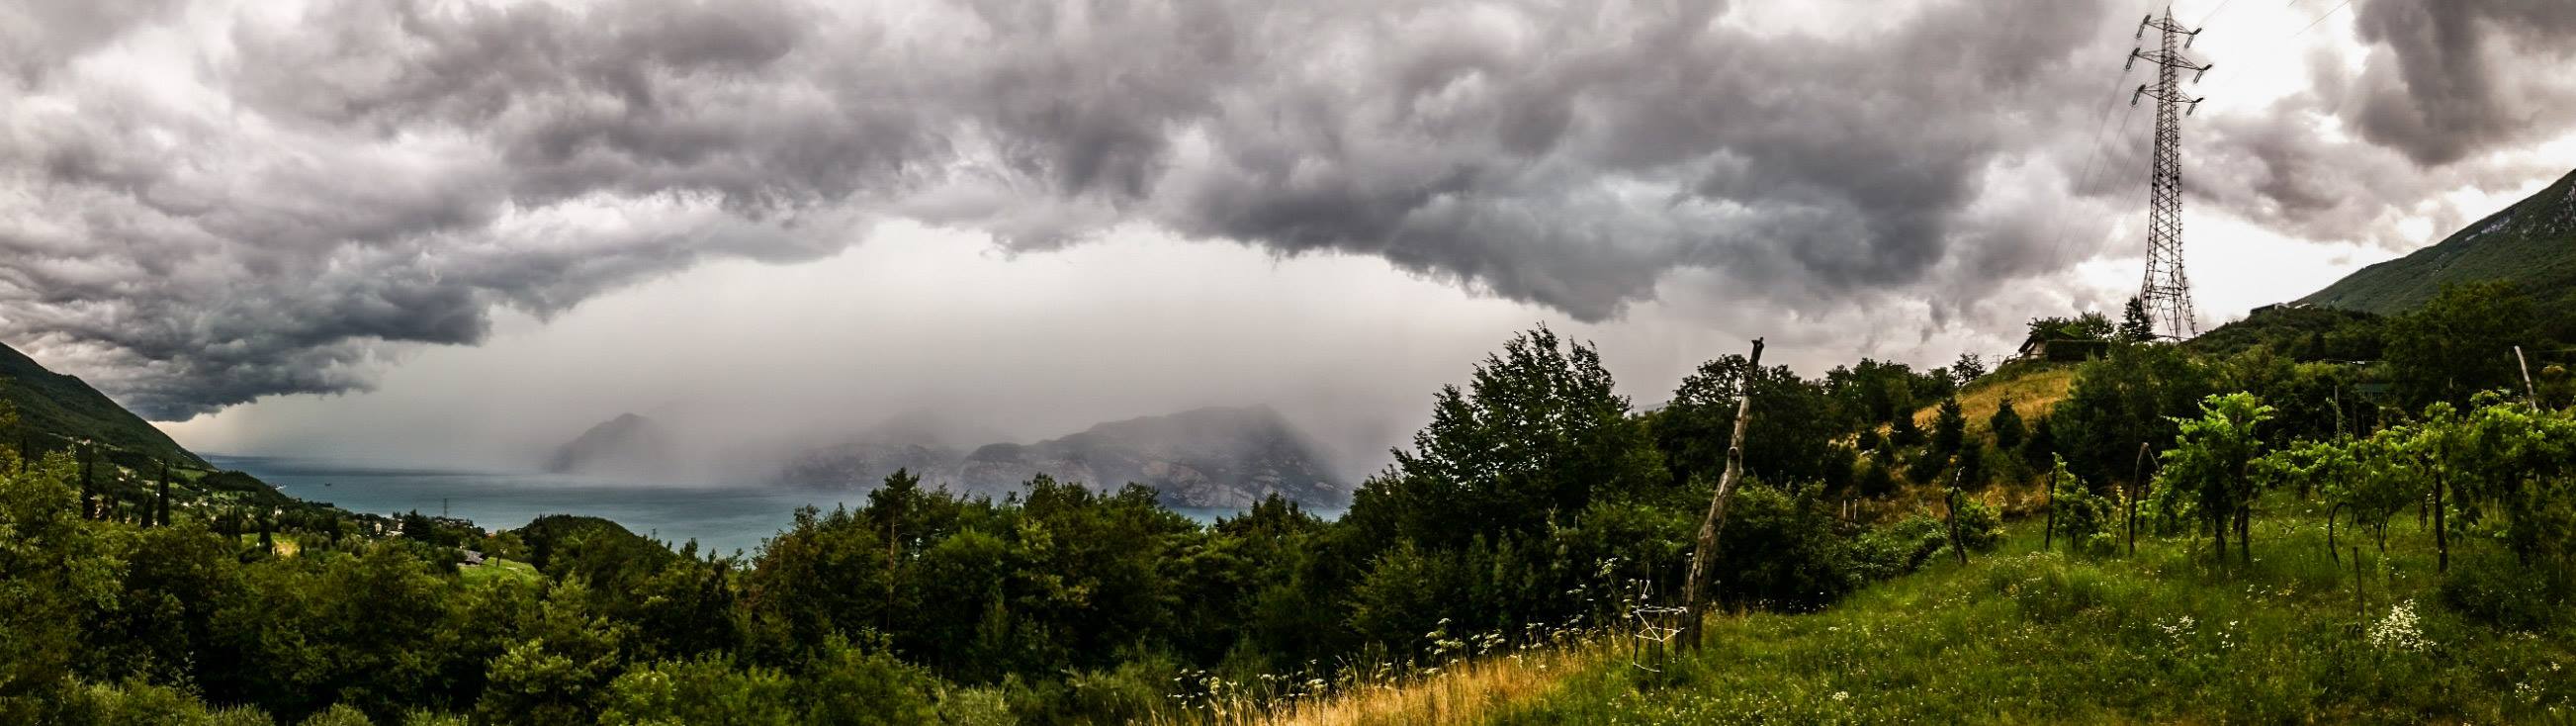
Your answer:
(206, 456), (1340, 554)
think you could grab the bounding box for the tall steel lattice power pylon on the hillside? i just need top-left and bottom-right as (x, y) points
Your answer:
(2128, 8), (2210, 340)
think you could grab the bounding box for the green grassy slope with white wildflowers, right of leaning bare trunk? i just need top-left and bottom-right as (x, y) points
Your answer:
(1491, 504), (2576, 723)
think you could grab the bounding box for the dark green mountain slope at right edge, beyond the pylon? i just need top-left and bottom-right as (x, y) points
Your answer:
(2298, 172), (2576, 315)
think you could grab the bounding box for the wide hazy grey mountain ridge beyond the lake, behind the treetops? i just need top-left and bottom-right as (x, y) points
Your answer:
(780, 407), (1350, 507)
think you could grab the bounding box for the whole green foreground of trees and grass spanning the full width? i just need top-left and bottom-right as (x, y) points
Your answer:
(0, 286), (2576, 723)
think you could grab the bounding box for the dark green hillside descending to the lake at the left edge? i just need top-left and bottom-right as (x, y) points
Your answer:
(0, 345), (206, 466)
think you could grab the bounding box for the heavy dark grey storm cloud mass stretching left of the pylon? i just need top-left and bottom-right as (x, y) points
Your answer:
(0, 0), (2542, 417)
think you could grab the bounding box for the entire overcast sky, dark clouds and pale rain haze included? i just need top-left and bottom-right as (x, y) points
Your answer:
(0, 0), (2576, 469)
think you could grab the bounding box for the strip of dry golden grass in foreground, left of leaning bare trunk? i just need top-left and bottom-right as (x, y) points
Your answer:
(1167, 636), (1634, 726)
